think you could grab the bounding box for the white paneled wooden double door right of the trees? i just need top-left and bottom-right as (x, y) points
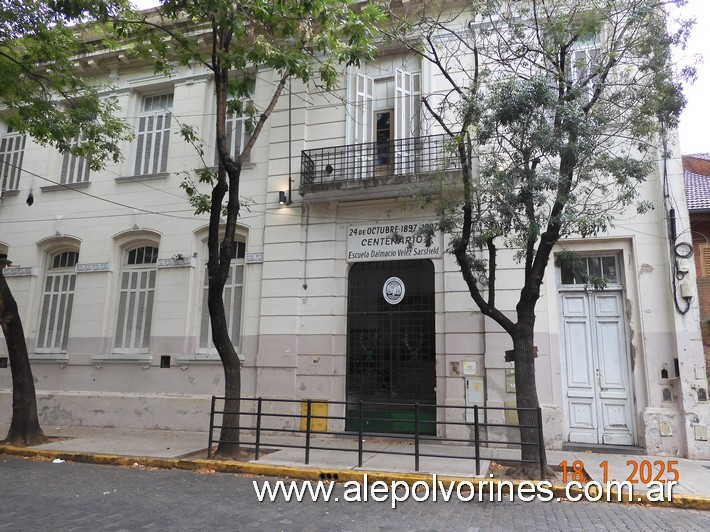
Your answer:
(561, 291), (634, 445)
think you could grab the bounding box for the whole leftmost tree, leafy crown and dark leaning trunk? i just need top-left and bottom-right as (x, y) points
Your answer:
(0, 0), (130, 445)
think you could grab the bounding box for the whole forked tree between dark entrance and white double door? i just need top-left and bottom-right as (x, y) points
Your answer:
(389, 0), (689, 475)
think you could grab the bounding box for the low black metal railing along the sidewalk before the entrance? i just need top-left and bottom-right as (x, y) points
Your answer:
(207, 396), (545, 478)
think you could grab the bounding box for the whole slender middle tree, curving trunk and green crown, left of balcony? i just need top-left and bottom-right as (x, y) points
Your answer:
(129, 0), (381, 457)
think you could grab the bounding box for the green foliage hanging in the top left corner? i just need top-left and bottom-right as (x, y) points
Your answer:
(0, 0), (131, 169)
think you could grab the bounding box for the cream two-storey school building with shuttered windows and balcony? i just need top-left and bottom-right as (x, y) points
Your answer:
(0, 5), (710, 458)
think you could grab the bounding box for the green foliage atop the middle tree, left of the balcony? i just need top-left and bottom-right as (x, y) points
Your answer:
(116, 0), (384, 212)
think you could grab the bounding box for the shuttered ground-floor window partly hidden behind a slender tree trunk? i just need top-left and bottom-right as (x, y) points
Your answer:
(198, 242), (246, 354)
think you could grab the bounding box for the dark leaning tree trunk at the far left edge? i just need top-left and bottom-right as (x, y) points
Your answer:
(0, 260), (49, 447)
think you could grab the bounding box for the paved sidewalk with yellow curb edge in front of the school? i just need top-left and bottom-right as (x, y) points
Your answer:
(0, 424), (710, 509)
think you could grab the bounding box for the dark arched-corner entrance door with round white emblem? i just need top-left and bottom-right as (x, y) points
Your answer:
(345, 260), (436, 434)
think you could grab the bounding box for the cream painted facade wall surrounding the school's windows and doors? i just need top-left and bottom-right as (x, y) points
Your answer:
(0, 17), (710, 457)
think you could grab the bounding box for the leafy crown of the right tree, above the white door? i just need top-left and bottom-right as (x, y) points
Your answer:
(409, 0), (689, 268)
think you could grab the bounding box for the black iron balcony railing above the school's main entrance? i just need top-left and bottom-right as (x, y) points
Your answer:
(301, 135), (460, 188)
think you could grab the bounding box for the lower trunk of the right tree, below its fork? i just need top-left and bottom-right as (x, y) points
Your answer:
(512, 318), (547, 478)
